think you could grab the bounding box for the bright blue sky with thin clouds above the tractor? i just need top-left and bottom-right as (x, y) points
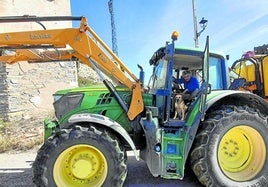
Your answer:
(71, 0), (268, 78)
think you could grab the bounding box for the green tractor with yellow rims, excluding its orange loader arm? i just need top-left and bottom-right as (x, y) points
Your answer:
(33, 37), (268, 187)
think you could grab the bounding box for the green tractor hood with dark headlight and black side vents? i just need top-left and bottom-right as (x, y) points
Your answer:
(53, 86), (131, 120)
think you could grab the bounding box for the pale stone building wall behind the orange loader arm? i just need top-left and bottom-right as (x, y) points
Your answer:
(0, 0), (77, 121)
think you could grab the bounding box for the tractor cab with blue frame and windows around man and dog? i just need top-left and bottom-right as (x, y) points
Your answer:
(149, 39), (229, 124)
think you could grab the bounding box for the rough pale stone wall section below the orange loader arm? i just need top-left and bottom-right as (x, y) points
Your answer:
(3, 62), (77, 120)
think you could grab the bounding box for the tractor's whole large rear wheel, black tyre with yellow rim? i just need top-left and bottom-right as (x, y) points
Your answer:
(191, 105), (268, 187)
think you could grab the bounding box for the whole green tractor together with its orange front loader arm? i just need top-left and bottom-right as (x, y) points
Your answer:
(0, 16), (268, 187)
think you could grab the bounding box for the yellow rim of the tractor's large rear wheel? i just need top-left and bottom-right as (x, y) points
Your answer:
(218, 125), (266, 181)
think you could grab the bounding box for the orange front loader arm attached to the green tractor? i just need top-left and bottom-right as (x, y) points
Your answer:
(0, 17), (144, 120)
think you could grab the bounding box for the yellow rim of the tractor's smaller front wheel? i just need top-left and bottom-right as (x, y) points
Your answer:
(53, 144), (108, 187)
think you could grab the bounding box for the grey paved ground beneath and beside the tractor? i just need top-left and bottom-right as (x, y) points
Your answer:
(0, 151), (201, 187)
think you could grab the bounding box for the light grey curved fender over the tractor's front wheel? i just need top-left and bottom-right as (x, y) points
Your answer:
(68, 113), (139, 160)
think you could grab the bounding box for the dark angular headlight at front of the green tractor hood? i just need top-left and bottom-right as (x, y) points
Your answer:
(53, 93), (84, 119)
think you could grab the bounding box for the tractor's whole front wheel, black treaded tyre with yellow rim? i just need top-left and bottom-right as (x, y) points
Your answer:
(33, 126), (127, 187)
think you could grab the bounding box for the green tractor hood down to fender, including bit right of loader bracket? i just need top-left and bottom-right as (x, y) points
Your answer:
(53, 86), (152, 130)
